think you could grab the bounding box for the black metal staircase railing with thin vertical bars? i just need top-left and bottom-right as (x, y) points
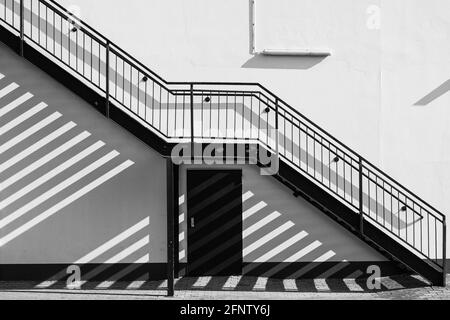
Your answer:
(0, 0), (446, 280)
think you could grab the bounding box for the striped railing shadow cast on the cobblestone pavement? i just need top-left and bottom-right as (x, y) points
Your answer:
(0, 275), (429, 296)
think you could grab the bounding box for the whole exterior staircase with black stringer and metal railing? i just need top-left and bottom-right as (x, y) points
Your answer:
(0, 0), (446, 285)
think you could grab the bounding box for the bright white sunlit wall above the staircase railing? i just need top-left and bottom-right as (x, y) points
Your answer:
(55, 0), (450, 255)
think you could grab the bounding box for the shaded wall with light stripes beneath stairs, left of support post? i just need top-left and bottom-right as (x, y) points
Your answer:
(0, 40), (167, 265)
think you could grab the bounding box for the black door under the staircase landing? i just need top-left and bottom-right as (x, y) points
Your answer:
(187, 170), (242, 276)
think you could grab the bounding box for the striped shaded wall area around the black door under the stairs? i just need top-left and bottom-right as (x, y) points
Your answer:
(179, 165), (386, 262)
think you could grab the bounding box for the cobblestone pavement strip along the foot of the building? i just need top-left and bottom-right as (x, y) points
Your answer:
(0, 275), (450, 300)
